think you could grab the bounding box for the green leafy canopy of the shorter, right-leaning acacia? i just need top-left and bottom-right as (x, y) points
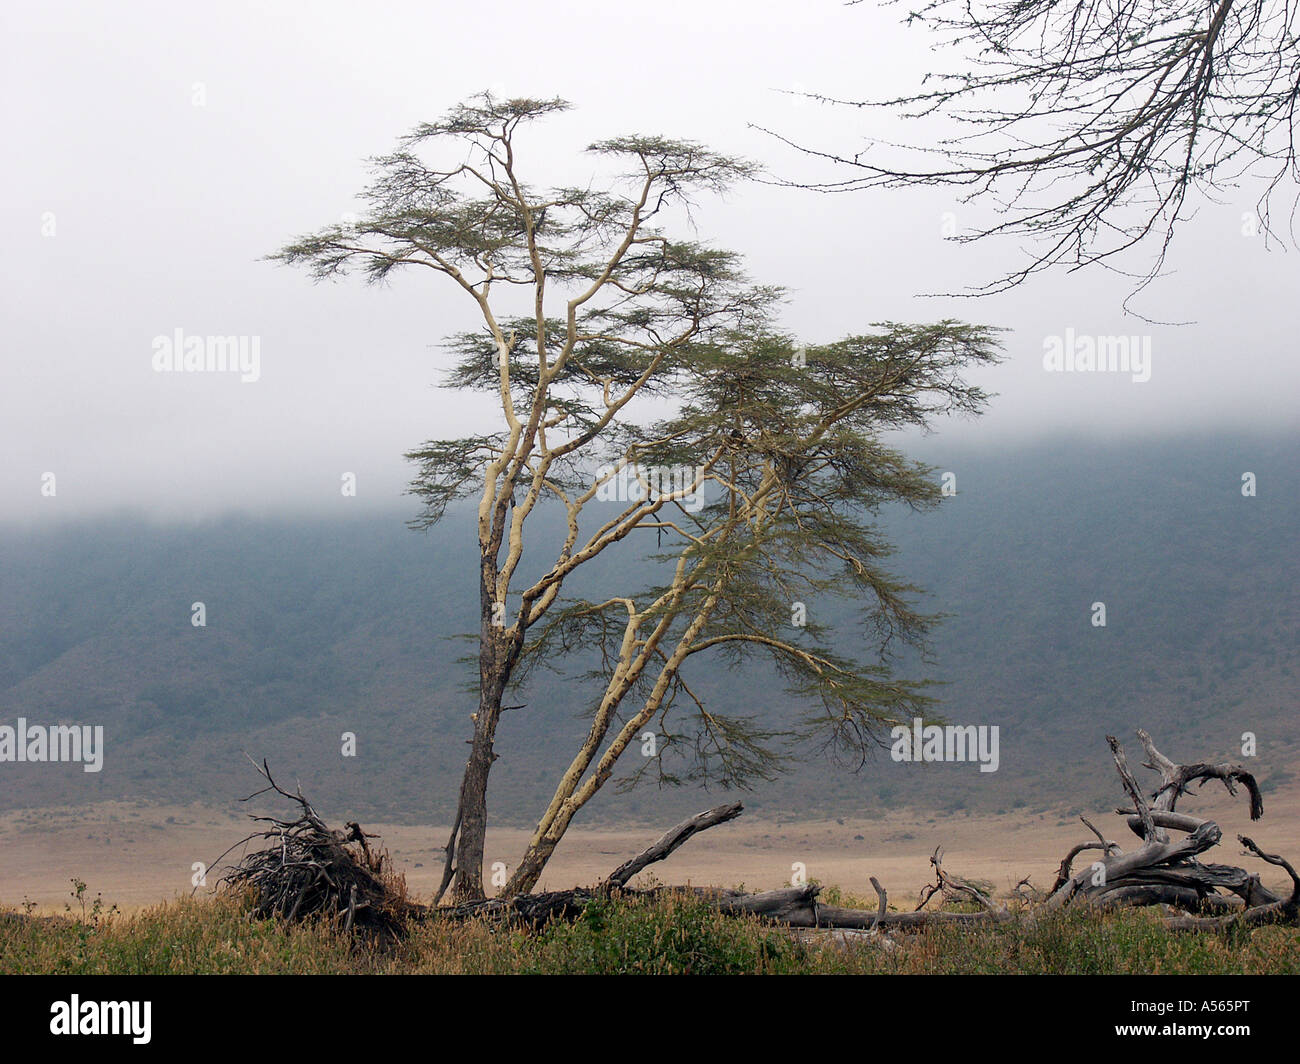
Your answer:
(506, 321), (997, 787)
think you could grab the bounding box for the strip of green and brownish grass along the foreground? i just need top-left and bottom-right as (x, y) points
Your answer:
(0, 898), (1300, 974)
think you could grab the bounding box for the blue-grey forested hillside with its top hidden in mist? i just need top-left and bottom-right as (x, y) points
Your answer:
(0, 437), (1300, 823)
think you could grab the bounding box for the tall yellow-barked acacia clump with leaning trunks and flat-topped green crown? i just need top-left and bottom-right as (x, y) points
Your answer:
(274, 95), (997, 901)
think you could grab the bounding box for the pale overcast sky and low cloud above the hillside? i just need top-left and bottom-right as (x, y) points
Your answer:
(0, 0), (1300, 520)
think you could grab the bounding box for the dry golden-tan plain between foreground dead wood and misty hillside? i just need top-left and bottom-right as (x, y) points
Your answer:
(10, 782), (1300, 912)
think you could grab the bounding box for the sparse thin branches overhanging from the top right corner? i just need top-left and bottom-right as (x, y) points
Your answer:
(781, 0), (1300, 303)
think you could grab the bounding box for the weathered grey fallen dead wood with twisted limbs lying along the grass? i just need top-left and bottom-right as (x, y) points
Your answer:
(220, 730), (1300, 943)
